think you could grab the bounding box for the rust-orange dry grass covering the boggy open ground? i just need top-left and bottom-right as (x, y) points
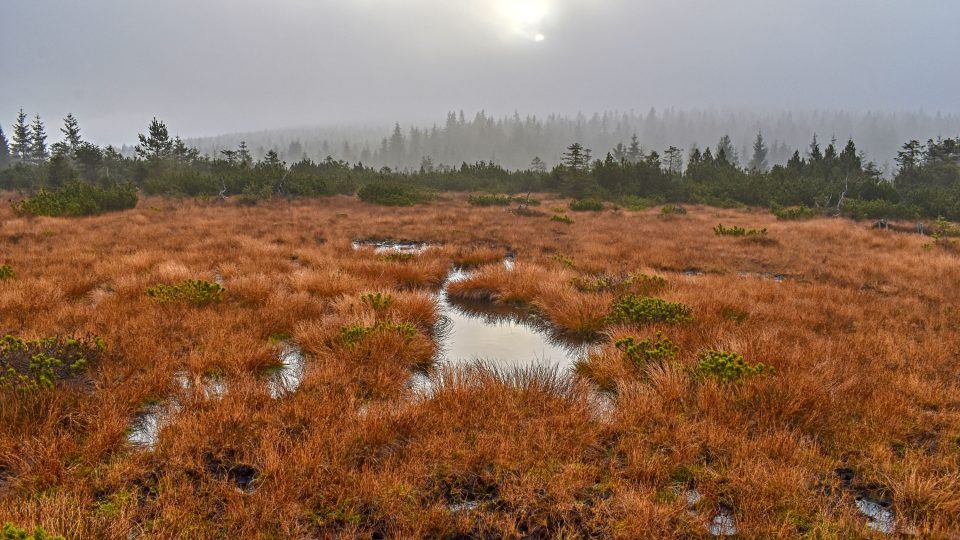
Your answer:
(0, 197), (960, 538)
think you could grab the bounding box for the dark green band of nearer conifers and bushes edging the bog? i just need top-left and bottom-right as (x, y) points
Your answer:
(0, 112), (960, 220)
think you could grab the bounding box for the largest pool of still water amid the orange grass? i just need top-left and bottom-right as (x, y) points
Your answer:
(437, 270), (586, 371)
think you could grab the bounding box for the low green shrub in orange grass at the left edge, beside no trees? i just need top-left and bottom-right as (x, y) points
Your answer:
(0, 335), (106, 391)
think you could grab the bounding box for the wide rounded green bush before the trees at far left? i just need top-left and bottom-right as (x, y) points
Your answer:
(13, 181), (137, 217)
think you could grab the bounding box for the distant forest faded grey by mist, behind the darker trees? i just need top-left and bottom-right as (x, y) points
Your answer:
(182, 109), (960, 174)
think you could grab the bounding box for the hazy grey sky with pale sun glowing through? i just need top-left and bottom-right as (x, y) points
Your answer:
(0, 0), (960, 143)
